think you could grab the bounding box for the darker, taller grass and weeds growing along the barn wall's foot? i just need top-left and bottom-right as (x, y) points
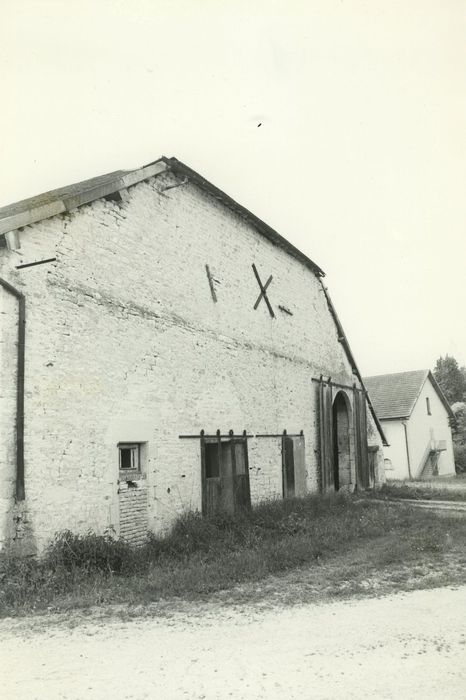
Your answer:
(0, 495), (458, 615)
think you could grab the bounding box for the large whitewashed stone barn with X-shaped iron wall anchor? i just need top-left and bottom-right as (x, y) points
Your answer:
(0, 158), (384, 553)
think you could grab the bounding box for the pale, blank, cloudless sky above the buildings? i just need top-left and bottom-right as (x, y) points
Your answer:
(0, 0), (466, 375)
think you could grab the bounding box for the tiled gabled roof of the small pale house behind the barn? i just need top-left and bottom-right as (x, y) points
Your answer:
(364, 369), (454, 420)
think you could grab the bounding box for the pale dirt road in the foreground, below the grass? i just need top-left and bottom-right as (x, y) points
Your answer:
(0, 586), (466, 700)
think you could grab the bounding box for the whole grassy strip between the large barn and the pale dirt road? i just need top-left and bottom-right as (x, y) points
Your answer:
(0, 495), (466, 616)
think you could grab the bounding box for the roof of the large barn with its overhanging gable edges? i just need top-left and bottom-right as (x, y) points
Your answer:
(0, 156), (325, 277)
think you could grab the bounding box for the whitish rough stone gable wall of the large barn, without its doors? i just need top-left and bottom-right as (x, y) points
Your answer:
(0, 175), (378, 548)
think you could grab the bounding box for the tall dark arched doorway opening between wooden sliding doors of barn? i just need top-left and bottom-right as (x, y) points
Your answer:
(332, 391), (351, 491)
